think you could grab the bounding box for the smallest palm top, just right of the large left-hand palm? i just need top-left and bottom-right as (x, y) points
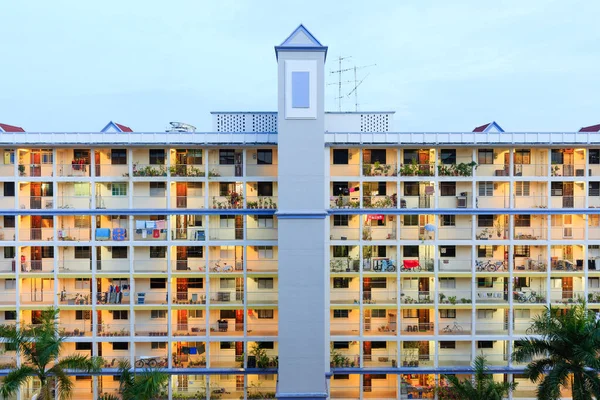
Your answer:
(111, 361), (169, 400)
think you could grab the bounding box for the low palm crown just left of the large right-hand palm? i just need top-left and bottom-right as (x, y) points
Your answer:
(437, 355), (517, 400)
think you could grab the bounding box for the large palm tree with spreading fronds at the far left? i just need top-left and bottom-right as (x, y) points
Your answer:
(0, 308), (103, 400)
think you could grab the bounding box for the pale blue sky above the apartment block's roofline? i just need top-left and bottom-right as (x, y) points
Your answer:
(0, 0), (600, 131)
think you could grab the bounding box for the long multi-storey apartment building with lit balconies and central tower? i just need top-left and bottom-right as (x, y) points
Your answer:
(0, 25), (600, 399)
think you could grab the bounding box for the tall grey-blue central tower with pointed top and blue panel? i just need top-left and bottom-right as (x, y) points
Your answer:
(275, 25), (329, 399)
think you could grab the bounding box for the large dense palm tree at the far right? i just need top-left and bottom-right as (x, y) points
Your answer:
(513, 301), (600, 400)
